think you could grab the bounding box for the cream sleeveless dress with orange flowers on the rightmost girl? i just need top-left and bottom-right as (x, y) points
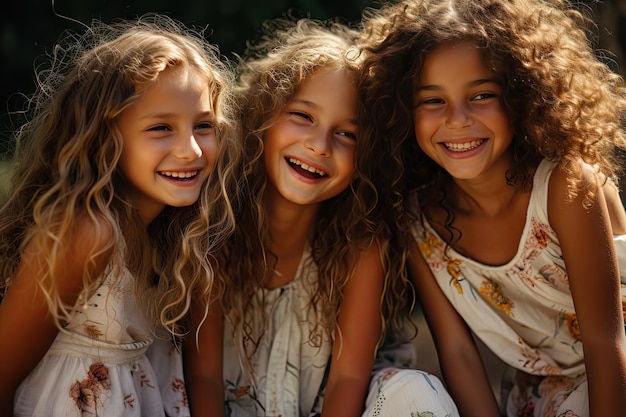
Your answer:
(412, 160), (626, 417)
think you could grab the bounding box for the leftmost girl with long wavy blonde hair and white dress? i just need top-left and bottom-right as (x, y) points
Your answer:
(0, 15), (239, 416)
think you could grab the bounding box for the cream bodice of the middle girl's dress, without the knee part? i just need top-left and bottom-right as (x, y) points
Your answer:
(223, 247), (332, 417)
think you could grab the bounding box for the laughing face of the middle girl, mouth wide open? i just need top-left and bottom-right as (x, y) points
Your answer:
(263, 69), (357, 205)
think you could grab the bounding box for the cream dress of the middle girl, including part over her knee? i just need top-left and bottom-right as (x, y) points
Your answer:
(224, 248), (458, 417)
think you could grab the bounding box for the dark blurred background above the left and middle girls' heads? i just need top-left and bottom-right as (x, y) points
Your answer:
(0, 0), (375, 156)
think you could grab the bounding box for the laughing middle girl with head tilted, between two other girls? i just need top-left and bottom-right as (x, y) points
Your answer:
(185, 18), (457, 417)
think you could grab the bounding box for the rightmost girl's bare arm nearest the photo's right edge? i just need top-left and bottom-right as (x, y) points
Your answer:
(548, 168), (624, 344)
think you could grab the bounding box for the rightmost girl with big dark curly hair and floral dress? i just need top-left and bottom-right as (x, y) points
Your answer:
(359, 0), (626, 416)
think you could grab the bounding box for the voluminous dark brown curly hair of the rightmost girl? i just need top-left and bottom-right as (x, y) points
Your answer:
(359, 0), (626, 247)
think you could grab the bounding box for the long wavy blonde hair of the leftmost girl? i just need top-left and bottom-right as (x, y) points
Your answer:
(0, 15), (241, 334)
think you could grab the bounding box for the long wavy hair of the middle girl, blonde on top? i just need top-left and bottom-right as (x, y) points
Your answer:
(219, 16), (414, 366)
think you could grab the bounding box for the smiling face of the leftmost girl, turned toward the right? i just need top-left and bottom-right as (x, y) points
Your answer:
(118, 69), (217, 224)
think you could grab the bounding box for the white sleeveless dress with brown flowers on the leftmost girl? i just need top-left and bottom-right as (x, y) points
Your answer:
(14, 269), (189, 417)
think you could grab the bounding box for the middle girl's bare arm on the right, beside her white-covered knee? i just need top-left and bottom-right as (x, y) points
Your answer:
(322, 245), (383, 417)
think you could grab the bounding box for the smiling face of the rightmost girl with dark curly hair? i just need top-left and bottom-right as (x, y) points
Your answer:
(413, 42), (513, 180)
